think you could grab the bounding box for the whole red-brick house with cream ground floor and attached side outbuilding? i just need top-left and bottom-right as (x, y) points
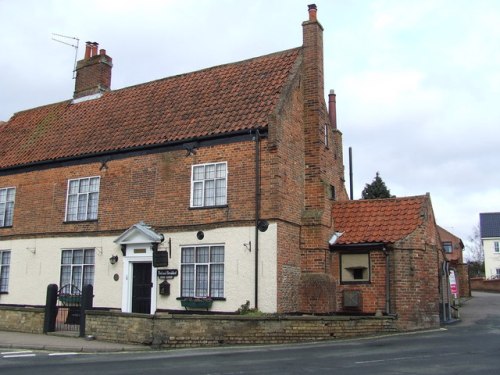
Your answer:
(0, 5), (441, 328)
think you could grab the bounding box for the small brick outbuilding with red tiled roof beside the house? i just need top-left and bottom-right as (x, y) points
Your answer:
(330, 195), (449, 329)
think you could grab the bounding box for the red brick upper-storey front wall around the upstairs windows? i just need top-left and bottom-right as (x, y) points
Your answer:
(0, 141), (262, 236)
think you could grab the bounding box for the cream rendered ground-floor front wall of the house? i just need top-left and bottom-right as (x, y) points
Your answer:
(0, 224), (277, 312)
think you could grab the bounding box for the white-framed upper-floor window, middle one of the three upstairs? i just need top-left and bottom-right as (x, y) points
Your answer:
(64, 176), (101, 223)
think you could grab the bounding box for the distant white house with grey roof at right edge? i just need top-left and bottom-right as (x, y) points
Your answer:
(479, 212), (500, 279)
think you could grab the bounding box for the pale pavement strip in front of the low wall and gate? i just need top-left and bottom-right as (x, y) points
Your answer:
(0, 331), (151, 353)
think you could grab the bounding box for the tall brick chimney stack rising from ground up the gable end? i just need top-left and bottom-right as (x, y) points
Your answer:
(298, 4), (346, 313)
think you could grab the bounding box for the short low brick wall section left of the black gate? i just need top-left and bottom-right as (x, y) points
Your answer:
(0, 306), (45, 333)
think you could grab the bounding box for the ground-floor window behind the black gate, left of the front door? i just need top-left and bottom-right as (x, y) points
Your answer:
(59, 247), (96, 294)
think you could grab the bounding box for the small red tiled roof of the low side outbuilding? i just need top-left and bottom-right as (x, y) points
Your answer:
(333, 195), (428, 245)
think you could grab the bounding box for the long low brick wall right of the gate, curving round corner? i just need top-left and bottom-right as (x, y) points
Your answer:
(86, 311), (398, 348)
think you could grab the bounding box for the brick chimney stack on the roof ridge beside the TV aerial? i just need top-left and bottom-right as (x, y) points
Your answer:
(73, 42), (113, 99)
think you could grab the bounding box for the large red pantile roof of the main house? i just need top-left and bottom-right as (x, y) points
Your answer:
(0, 48), (301, 169)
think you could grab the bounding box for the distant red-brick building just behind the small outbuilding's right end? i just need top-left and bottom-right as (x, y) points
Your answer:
(438, 226), (470, 298)
